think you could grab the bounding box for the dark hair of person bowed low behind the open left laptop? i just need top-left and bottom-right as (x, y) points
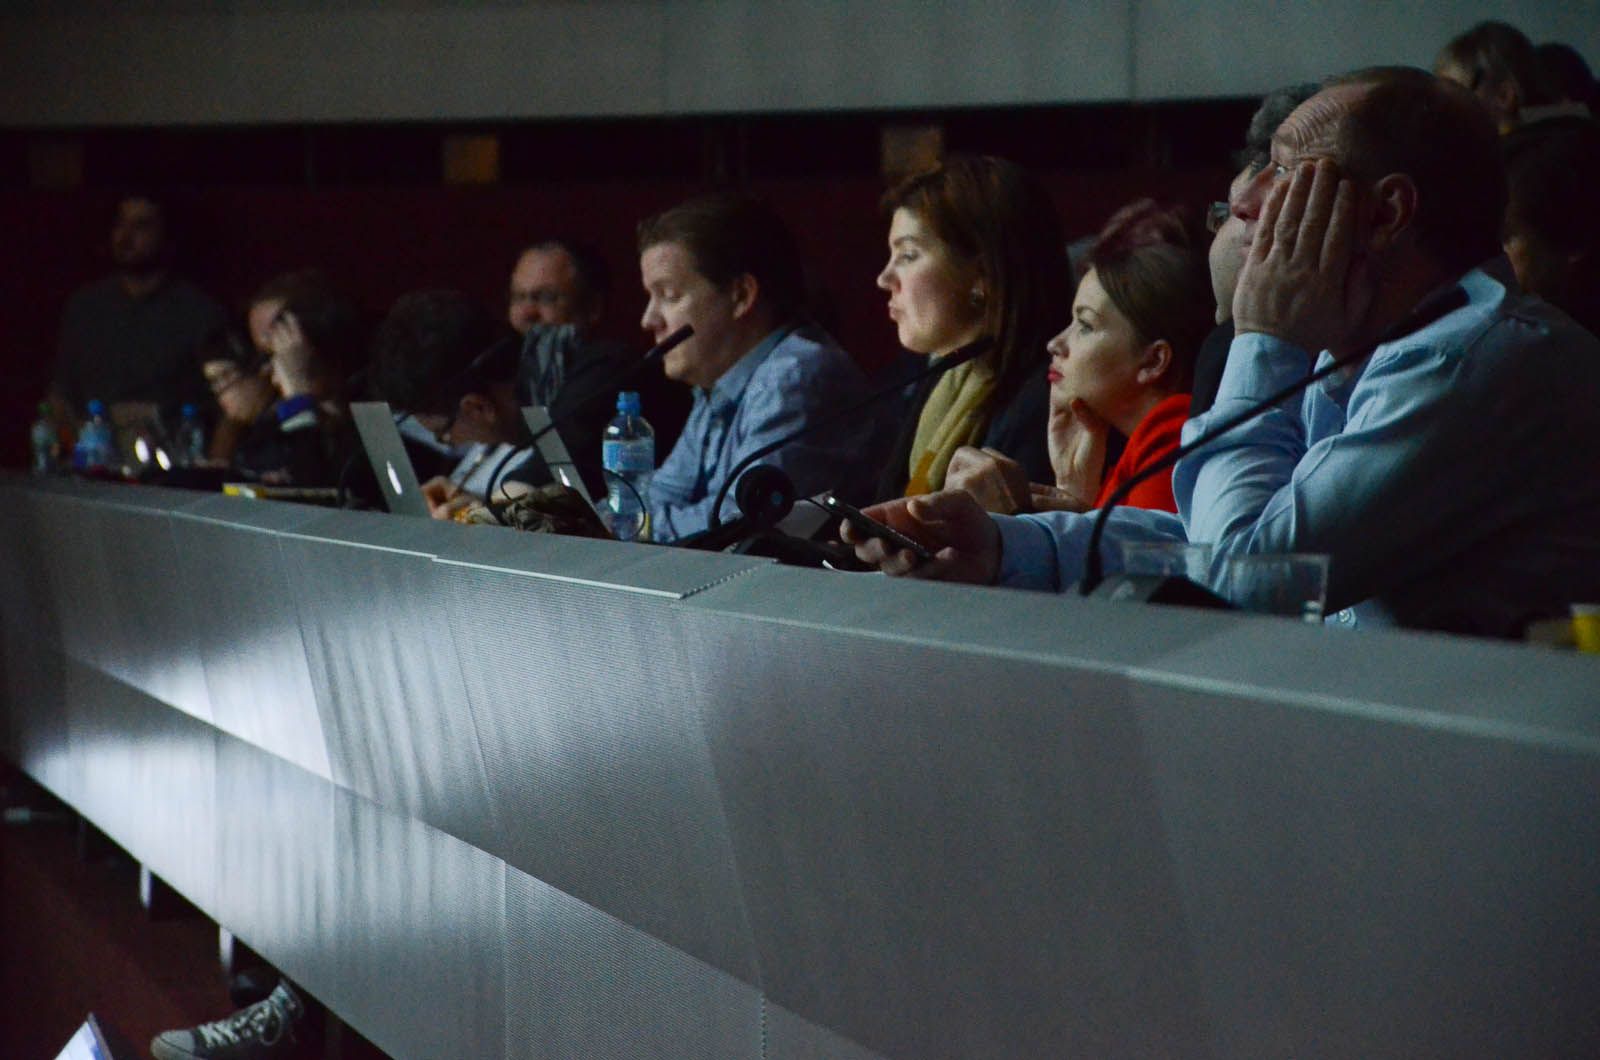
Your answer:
(370, 291), (522, 413)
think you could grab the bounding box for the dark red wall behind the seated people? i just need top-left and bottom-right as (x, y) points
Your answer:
(0, 168), (1227, 466)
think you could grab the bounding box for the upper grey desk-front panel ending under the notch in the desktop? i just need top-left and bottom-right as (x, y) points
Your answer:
(450, 567), (755, 982)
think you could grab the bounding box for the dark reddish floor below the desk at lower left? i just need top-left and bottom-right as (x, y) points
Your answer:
(0, 764), (393, 1060)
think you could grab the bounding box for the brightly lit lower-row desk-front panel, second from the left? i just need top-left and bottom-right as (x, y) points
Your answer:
(66, 661), (218, 905)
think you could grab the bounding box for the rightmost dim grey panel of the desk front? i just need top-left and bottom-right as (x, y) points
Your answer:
(1139, 689), (1600, 1057)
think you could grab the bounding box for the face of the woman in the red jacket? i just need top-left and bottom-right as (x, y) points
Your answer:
(1048, 269), (1146, 424)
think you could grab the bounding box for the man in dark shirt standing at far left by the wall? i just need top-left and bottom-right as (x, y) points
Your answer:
(51, 195), (224, 423)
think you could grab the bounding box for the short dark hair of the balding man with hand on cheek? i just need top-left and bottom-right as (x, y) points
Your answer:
(1328, 66), (1506, 272)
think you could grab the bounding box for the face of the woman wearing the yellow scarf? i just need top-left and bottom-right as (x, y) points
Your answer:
(878, 207), (984, 355)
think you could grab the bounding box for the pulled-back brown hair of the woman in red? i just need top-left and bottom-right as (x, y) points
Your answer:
(1088, 199), (1216, 391)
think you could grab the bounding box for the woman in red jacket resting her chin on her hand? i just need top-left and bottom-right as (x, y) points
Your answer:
(947, 200), (1214, 512)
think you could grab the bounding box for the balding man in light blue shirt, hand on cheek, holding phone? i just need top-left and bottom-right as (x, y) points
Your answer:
(856, 69), (1600, 636)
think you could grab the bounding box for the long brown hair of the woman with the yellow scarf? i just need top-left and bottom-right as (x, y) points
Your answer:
(882, 155), (1072, 402)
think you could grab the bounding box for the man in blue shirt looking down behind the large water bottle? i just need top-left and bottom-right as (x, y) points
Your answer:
(638, 194), (874, 541)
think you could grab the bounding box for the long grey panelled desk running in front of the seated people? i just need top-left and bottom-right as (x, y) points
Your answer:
(0, 479), (1600, 1060)
